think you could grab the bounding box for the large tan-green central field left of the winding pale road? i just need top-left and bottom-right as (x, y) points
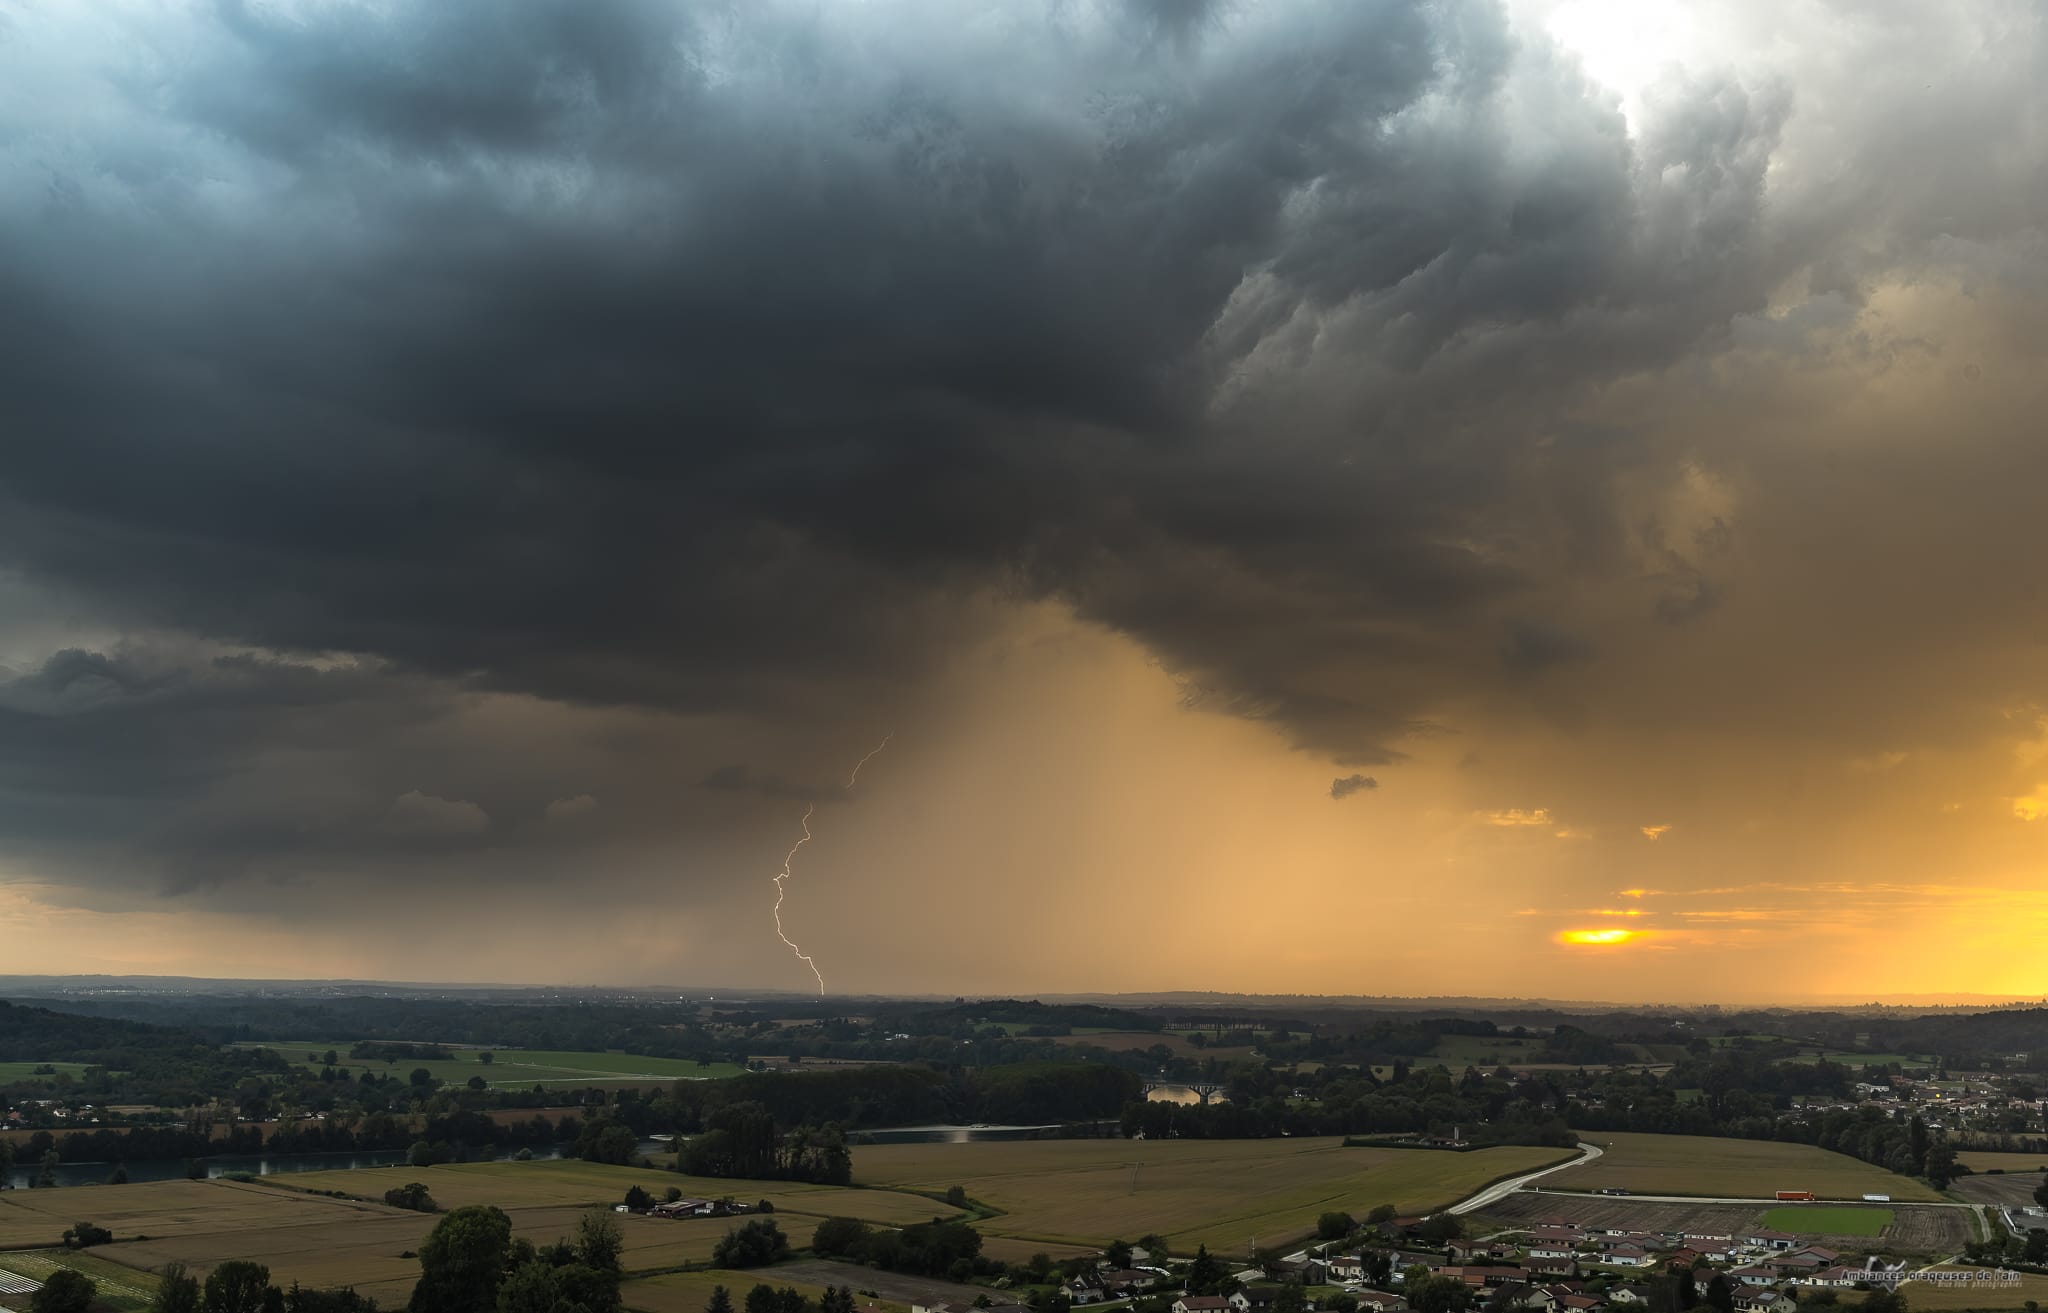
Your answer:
(854, 1139), (1571, 1254)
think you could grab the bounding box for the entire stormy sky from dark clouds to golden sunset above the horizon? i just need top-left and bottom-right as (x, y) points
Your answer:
(0, 0), (2048, 998)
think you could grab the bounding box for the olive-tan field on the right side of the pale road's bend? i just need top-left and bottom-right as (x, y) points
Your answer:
(1544, 1131), (1942, 1202)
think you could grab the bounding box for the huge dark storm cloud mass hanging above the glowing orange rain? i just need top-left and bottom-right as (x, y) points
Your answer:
(0, 0), (2048, 983)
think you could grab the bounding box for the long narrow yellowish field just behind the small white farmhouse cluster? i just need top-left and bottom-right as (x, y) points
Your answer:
(266, 1151), (956, 1233)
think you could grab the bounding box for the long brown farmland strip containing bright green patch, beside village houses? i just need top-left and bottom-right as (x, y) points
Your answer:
(1475, 1190), (1974, 1258)
